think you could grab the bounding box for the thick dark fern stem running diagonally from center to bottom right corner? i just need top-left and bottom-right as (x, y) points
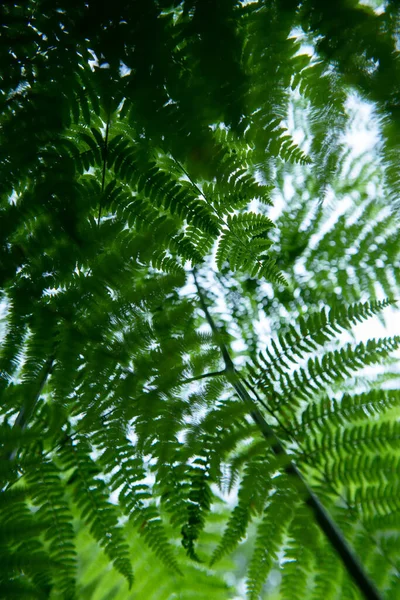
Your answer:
(193, 271), (382, 600)
